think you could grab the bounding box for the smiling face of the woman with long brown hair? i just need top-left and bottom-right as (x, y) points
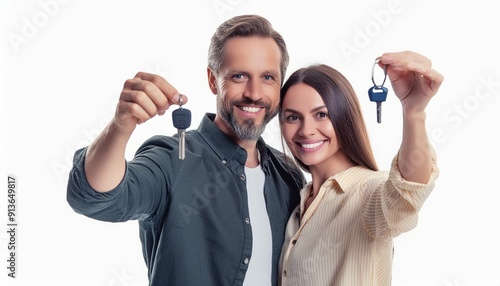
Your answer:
(281, 83), (343, 167)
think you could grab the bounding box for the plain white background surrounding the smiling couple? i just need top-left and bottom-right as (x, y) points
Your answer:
(0, 0), (500, 286)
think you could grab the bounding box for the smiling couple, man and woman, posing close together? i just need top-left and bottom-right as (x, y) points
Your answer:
(67, 15), (443, 286)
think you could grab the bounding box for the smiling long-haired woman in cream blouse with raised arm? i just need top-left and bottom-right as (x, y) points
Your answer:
(279, 52), (443, 286)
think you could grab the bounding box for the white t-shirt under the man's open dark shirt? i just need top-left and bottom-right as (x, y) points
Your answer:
(243, 166), (273, 286)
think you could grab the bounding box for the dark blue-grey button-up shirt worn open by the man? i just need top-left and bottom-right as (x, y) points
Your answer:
(67, 114), (305, 286)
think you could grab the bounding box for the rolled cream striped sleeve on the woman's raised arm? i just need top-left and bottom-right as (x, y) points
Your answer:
(363, 147), (439, 239)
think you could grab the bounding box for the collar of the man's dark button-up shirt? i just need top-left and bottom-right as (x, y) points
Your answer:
(197, 113), (269, 167)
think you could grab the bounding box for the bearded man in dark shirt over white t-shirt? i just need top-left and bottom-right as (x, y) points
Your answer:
(67, 15), (304, 286)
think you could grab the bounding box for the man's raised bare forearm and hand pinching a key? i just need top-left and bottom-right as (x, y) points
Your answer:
(85, 72), (187, 192)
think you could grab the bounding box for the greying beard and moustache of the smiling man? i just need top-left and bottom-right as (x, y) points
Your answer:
(217, 97), (278, 141)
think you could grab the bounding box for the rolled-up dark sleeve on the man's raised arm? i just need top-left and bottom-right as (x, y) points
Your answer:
(67, 142), (172, 222)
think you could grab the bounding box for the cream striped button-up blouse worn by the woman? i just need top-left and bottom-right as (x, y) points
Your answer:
(278, 152), (439, 286)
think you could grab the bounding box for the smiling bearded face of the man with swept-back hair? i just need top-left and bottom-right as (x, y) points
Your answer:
(209, 37), (282, 141)
